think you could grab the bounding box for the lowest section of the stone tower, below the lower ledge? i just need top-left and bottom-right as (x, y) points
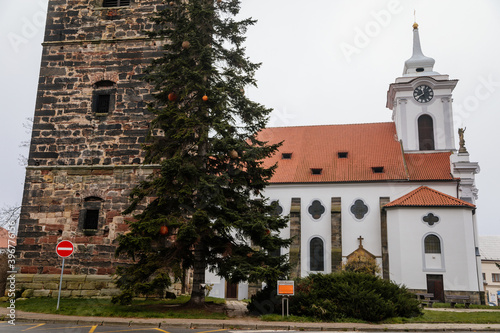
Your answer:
(17, 166), (153, 274)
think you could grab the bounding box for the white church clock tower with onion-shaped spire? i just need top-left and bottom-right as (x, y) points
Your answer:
(386, 23), (458, 152)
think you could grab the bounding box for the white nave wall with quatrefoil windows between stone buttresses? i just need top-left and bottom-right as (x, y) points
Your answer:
(264, 182), (456, 276)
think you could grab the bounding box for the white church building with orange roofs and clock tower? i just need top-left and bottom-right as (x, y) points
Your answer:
(206, 24), (483, 303)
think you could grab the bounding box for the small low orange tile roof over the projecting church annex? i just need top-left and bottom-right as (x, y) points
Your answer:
(384, 186), (476, 208)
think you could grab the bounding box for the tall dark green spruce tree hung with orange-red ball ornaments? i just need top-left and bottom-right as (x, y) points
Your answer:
(115, 0), (290, 304)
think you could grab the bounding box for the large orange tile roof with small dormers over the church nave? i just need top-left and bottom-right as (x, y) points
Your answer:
(259, 122), (453, 183)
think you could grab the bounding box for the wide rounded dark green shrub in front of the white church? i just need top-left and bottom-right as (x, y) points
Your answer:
(290, 271), (422, 321)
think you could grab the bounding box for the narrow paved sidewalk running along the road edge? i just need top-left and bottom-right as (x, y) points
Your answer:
(0, 302), (500, 332)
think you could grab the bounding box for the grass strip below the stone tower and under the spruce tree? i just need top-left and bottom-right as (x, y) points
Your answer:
(0, 296), (227, 319)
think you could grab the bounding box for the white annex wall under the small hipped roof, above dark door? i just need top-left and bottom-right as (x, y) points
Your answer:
(387, 208), (478, 291)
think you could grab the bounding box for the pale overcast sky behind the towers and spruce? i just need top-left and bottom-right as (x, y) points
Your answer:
(0, 0), (500, 235)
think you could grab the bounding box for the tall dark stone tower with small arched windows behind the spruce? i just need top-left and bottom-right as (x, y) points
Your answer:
(16, 0), (164, 286)
